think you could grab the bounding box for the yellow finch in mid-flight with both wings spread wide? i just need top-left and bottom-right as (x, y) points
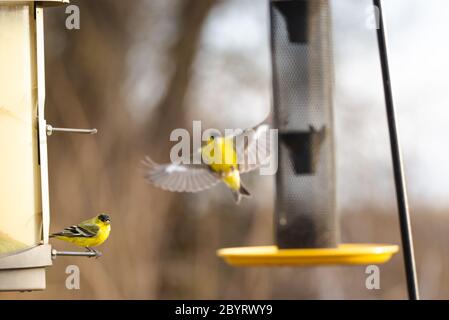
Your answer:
(143, 125), (270, 204)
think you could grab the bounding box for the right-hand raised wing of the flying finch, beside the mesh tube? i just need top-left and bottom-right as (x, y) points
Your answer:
(234, 124), (273, 173)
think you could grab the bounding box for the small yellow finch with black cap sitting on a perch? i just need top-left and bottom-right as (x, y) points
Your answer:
(50, 214), (111, 254)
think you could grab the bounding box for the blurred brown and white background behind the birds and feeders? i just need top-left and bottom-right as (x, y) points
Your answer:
(0, 0), (449, 299)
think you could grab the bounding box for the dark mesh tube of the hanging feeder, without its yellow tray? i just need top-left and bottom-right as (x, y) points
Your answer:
(271, 1), (339, 248)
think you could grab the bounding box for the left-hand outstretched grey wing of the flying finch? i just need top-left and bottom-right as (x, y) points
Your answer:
(143, 157), (220, 192)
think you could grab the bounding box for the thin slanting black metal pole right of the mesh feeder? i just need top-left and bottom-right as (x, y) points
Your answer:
(373, 0), (419, 300)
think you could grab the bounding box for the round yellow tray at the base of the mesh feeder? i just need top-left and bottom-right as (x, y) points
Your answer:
(217, 243), (399, 267)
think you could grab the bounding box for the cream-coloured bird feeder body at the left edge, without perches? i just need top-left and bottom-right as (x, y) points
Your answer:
(0, 0), (68, 291)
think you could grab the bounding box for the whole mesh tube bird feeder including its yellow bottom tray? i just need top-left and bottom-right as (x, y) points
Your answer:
(218, 0), (398, 266)
